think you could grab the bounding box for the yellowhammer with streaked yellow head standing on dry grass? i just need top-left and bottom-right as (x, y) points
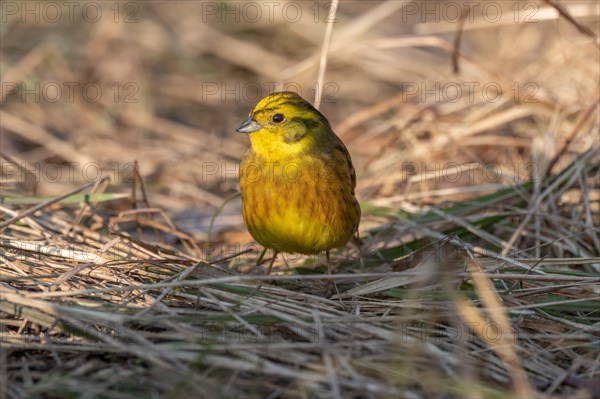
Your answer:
(236, 91), (360, 274)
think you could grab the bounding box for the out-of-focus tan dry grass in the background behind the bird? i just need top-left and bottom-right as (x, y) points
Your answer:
(0, 1), (600, 244)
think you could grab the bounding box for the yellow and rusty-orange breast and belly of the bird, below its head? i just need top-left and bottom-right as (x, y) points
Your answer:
(240, 151), (360, 254)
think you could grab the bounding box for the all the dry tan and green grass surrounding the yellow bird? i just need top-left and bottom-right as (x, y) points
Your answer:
(0, 0), (600, 398)
